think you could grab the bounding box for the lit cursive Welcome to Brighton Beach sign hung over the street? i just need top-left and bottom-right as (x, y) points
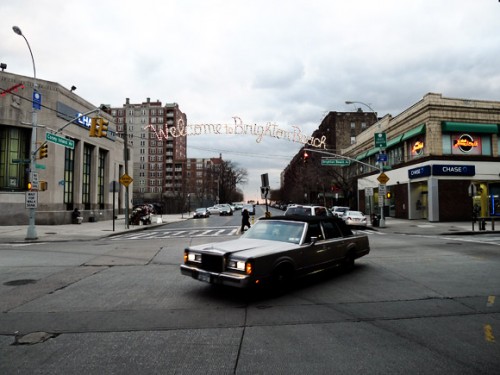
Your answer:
(145, 117), (326, 149)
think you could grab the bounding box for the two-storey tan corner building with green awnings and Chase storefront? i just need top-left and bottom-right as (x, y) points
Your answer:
(342, 93), (500, 222)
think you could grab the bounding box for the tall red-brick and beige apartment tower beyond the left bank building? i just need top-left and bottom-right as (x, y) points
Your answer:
(111, 98), (189, 212)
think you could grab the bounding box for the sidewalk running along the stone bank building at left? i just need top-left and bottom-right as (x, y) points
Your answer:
(0, 213), (190, 243)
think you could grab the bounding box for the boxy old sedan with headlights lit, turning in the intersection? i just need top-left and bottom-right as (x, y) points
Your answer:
(180, 215), (370, 288)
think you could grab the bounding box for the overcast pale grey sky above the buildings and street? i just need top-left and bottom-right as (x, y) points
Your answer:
(0, 0), (500, 204)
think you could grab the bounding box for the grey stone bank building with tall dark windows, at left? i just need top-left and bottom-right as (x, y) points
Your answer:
(0, 71), (125, 225)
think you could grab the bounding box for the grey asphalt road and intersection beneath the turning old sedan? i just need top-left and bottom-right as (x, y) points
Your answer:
(0, 207), (500, 374)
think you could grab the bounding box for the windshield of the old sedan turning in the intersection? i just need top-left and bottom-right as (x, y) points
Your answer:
(242, 220), (305, 244)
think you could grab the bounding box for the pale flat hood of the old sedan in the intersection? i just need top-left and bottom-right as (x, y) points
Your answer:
(189, 238), (300, 258)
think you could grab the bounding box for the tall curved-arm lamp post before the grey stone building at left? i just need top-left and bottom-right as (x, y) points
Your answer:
(12, 26), (40, 240)
